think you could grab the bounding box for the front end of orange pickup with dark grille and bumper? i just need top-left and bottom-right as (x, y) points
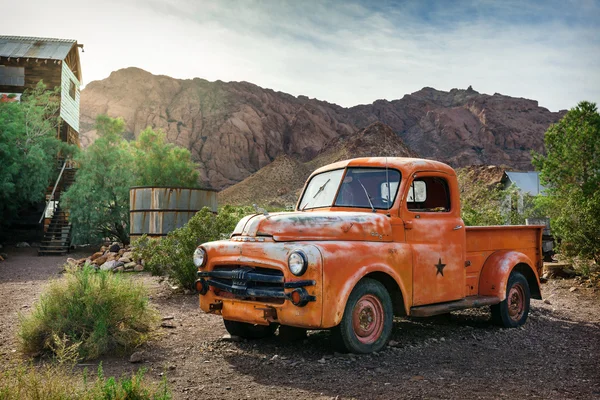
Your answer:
(196, 239), (323, 329)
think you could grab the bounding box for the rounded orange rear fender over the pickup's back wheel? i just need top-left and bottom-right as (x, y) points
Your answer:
(479, 250), (539, 300)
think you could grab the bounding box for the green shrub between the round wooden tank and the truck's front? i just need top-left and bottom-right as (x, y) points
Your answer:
(134, 206), (254, 289)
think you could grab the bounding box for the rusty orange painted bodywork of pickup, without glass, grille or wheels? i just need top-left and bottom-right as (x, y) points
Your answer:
(196, 158), (543, 329)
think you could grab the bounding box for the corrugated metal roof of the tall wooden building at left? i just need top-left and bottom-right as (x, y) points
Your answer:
(0, 36), (77, 60)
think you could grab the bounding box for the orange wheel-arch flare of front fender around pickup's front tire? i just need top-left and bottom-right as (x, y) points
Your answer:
(323, 264), (410, 328)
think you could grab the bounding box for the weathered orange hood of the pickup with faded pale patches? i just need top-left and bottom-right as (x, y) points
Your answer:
(232, 211), (392, 242)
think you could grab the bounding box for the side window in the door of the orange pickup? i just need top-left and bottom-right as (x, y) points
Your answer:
(406, 176), (450, 212)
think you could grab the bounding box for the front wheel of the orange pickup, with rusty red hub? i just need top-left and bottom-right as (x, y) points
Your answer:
(333, 278), (394, 354)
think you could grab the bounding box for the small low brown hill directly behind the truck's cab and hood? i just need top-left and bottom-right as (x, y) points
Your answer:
(218, 122), (418, 207)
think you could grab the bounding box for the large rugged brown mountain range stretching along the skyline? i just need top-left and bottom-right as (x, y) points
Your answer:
(81, 68), (563, 189)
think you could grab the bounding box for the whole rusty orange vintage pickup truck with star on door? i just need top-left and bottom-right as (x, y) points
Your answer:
(193, 157), (543, 353)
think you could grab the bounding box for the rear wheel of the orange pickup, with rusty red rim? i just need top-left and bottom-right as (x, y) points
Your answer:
(491, 271), (531, 328)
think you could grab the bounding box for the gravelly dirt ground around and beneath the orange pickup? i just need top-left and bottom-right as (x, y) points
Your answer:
(0, 248), (600, 399)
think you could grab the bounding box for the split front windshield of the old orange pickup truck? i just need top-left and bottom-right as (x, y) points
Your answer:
(300, 167), (400, 210)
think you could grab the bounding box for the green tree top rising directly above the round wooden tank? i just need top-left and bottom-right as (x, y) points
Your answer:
(131, 128), (198, 187)
